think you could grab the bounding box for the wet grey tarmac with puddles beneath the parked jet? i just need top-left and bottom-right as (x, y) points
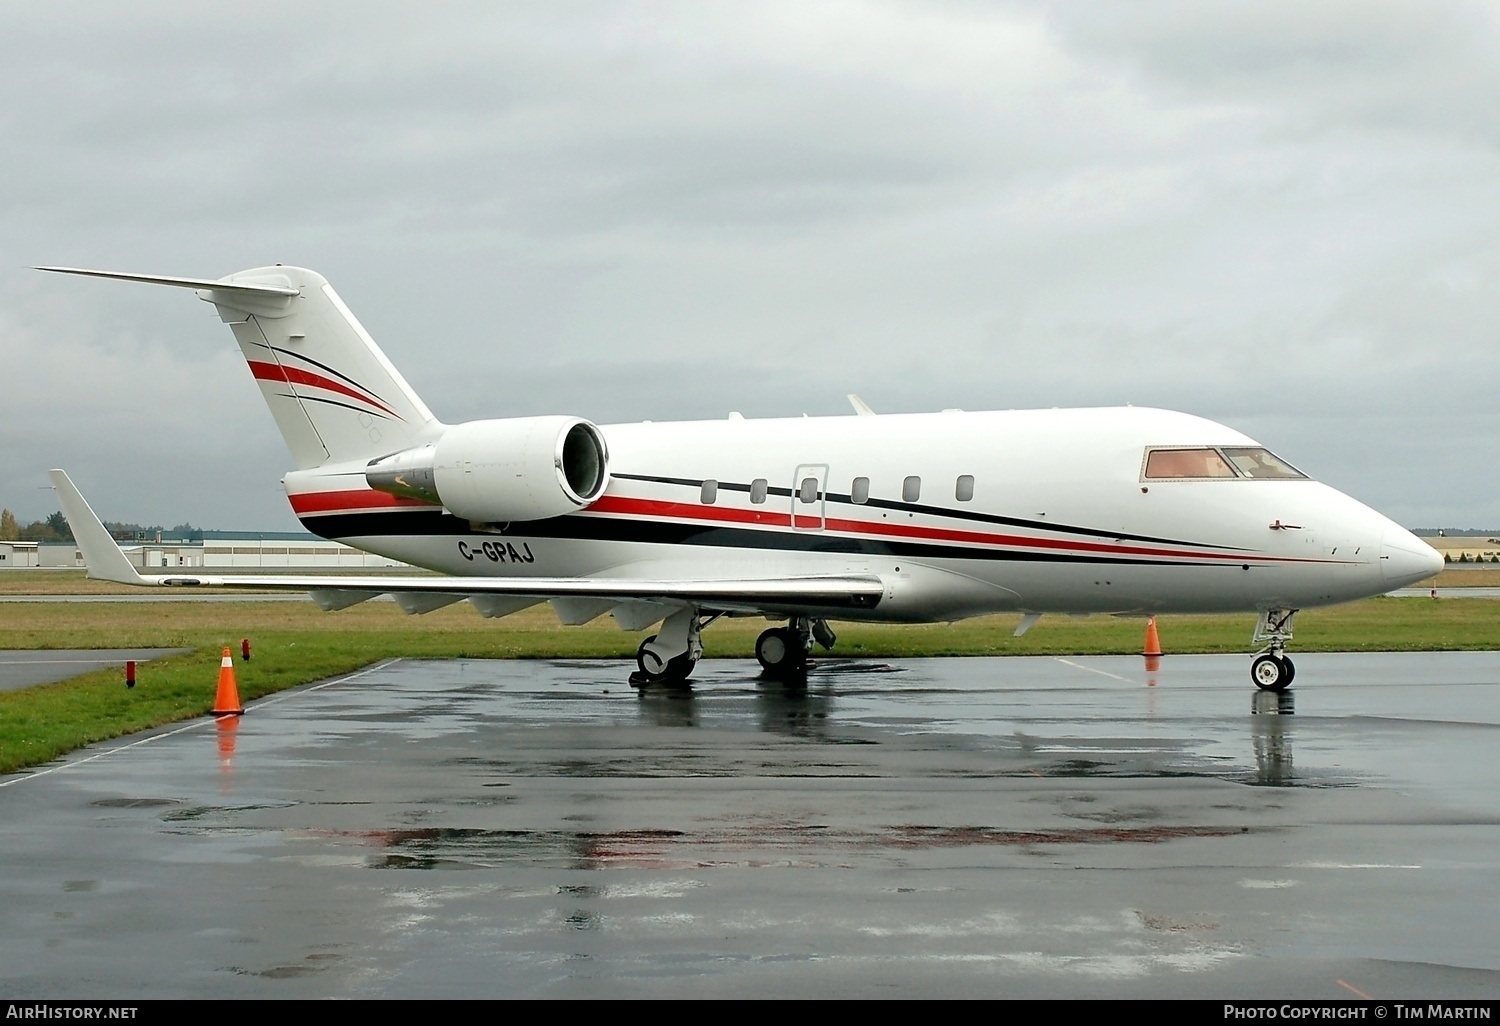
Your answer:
(0, 653), (1500, 999)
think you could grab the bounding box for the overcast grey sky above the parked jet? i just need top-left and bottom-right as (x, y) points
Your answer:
(0, 0), (1500, 530)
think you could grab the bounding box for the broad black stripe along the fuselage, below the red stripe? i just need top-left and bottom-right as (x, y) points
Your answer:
(300, 510), (1239, 567)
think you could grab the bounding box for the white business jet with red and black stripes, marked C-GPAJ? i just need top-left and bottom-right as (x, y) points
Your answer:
(39, 266), (1443, 692)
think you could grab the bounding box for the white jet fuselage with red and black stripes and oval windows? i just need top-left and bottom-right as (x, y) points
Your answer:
(285, 408), (1442, 621)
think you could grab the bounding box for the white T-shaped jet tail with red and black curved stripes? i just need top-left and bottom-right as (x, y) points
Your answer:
(41, 266), (440, 470)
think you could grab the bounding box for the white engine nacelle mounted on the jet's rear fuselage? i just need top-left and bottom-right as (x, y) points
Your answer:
(365, 417), (609, 524)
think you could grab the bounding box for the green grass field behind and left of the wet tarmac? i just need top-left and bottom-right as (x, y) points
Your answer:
(0, 588), (1500, 773)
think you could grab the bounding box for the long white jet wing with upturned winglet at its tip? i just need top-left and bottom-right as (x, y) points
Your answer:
(50, 470), (885, 612)
